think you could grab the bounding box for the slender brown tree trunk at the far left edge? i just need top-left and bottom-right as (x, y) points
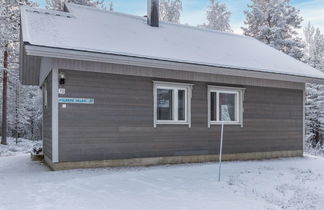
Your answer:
(1, 44), (8, 145)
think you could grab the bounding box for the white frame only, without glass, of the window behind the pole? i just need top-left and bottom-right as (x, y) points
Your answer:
(207, 85), (245, 128)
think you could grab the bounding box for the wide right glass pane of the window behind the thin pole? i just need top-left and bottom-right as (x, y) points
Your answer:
(219, 93), (236, 121)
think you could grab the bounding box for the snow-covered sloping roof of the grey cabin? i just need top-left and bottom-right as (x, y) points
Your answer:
(21, 4), (324, 79)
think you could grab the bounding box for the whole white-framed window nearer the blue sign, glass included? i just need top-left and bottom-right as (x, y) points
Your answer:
(154, 82), (192, 127)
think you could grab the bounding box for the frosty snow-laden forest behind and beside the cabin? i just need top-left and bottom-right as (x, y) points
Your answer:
(0, 0), (324, 151)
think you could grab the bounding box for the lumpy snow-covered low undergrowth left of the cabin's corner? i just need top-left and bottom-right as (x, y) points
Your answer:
(0, 137), (42, 157)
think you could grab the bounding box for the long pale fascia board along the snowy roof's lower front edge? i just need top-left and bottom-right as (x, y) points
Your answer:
(25, 45), (324, 84)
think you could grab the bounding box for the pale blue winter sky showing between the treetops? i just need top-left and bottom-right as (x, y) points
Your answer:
(36, 0), (324, 33)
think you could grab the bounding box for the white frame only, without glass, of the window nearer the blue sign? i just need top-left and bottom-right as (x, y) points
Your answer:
(153, 81), (193, 128)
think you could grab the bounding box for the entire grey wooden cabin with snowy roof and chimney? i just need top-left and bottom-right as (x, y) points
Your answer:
(20, 2), (324, 170)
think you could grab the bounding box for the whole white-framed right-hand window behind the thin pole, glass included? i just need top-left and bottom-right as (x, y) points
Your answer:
(208, 86), (244, 126)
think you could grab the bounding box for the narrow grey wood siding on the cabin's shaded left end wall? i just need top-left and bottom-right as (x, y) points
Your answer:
(43, 74), (52, 160)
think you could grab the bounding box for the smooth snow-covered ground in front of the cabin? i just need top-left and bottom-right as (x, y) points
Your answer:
(0, 155), (324, 210)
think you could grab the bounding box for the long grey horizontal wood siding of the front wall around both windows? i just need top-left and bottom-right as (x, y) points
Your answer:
(59, 70), (303, 161)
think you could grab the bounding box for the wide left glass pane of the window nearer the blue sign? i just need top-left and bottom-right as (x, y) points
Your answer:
(157, 89), (173, 120)
